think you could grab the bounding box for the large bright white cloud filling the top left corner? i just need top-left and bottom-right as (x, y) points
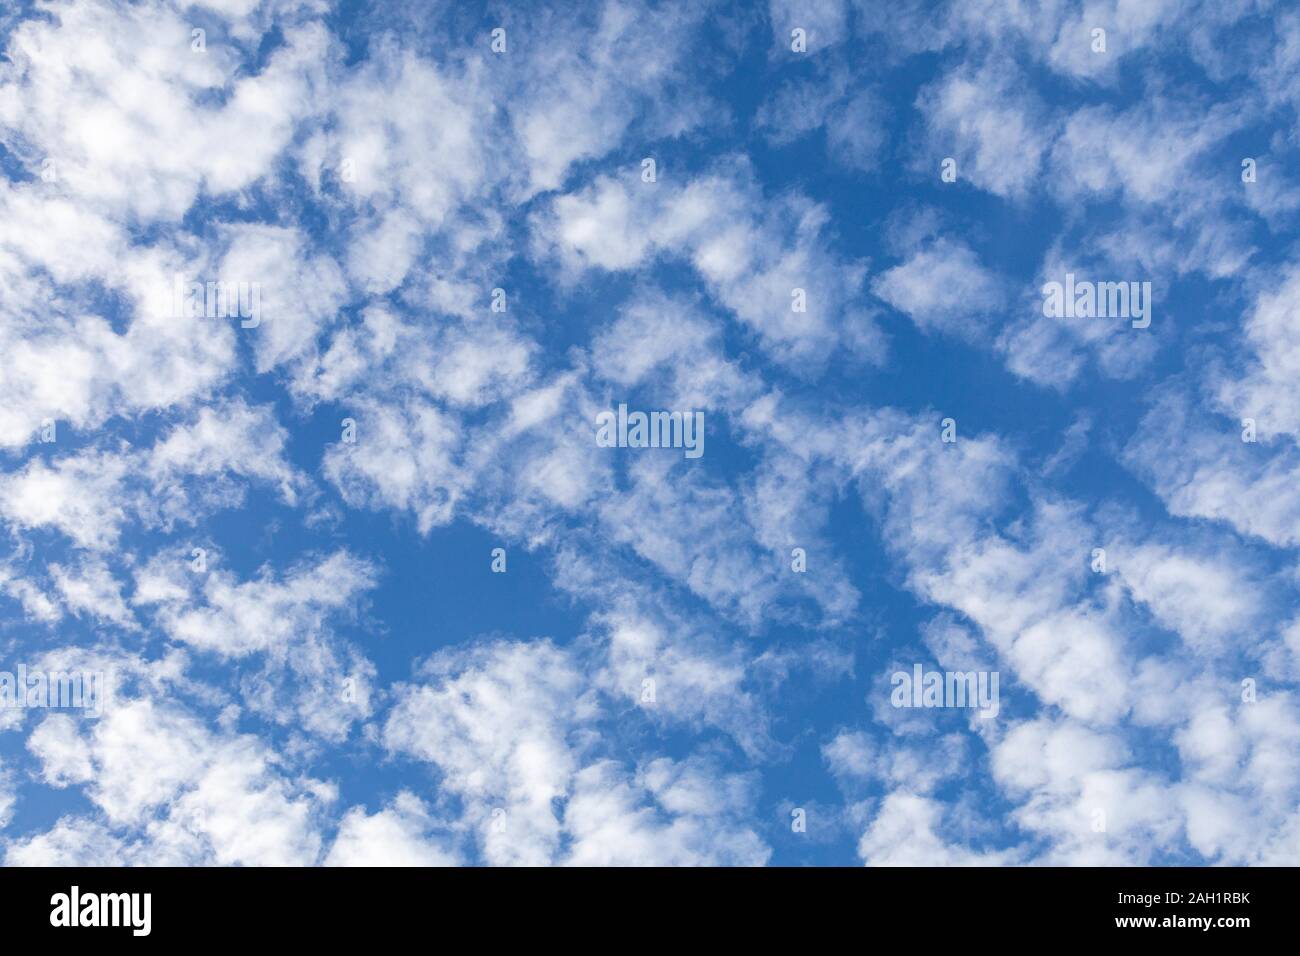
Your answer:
(0, 3), (329, 220)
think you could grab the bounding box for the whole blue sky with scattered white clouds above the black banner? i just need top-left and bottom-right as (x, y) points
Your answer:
(0, 0), (1300, 865)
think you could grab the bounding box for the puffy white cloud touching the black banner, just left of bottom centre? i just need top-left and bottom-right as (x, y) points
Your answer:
(382, 641), (768, 865)
